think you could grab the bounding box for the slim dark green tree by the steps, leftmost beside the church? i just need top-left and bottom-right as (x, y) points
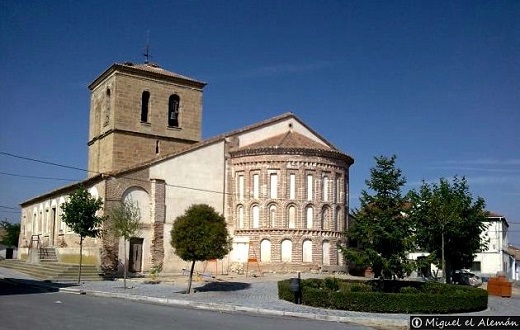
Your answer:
(61, 186), (104, 283)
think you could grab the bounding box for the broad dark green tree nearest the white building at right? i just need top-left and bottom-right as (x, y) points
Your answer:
(409, 176), (487, 283)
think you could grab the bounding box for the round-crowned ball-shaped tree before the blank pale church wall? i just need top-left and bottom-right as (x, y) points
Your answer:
(170, 204), (231, 293)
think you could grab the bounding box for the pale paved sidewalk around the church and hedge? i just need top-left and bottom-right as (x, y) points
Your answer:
(0, 268), (520, 329)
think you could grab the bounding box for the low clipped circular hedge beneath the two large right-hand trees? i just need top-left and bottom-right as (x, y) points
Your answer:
(278, 278), (488, 314)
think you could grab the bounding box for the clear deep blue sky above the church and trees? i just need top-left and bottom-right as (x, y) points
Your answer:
(0, 0), (520, 245)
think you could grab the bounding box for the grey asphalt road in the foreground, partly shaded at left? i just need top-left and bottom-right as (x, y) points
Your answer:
(0, 279), (371, 330)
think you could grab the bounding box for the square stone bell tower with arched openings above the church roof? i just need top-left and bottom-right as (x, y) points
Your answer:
(88, 62), (206, 176)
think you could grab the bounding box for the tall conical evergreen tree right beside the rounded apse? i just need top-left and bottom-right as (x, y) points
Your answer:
(340, 155), (413, 279)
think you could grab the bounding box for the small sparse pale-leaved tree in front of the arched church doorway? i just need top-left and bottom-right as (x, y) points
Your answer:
(105, 200), (141, 289)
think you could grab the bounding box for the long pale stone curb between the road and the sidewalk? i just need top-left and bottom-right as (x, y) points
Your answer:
(59, 288), (408, 329)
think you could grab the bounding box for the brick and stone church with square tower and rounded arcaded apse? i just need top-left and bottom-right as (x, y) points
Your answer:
(18, 62), (354, 273)
